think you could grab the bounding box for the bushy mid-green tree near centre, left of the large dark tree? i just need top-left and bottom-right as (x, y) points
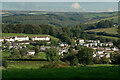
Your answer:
(46, 48), (60, 61)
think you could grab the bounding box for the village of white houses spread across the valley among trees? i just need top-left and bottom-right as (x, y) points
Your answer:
(0, 35), (119, 58)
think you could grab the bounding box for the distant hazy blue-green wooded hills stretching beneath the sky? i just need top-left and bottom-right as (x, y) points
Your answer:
(2, 11), (118, 27)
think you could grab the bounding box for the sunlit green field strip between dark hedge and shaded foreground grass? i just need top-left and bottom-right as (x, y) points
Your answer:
(7, 61), (50, 69)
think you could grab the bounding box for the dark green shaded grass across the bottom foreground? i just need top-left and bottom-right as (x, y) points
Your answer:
(3, 66), (119, 79)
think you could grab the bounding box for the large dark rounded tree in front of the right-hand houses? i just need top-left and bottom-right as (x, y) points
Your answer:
(77, 48), (93, 64)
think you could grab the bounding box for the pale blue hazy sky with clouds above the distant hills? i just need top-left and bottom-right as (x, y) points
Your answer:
(2, 2), (118, 12)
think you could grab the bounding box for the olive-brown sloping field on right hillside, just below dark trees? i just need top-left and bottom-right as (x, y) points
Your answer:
(85, 27), (118, 34)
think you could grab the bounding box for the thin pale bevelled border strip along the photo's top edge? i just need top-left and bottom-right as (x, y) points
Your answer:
(0, 0), (120, 2)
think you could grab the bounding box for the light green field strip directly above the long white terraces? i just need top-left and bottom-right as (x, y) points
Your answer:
(2, 33), (59, 40)
